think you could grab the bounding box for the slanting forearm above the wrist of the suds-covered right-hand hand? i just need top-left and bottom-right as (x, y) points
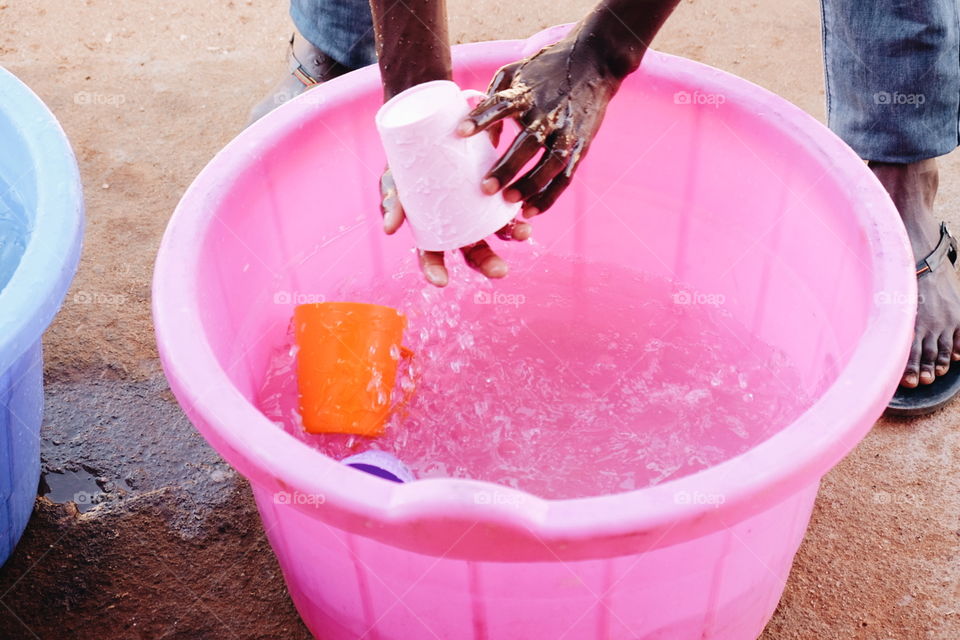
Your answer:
(568, 0), (680, 79)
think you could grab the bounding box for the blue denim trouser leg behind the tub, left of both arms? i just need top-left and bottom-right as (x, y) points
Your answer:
(290, 0), (377, 69)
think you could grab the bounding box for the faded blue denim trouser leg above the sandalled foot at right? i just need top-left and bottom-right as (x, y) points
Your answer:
(821, 0), (960, 162)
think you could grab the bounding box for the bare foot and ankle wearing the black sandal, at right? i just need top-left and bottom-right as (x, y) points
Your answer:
(870, 159), (960, 388)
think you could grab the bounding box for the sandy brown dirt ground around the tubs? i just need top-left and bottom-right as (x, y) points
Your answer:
(0, 0), (960, 640)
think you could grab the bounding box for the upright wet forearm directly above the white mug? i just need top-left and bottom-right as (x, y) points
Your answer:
(370, 0), (452, 100)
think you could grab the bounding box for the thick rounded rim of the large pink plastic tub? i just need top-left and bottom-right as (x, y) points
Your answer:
(153, 26), (916, 561)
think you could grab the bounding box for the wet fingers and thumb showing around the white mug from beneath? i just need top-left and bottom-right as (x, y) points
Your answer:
(380, 168), (532, 287)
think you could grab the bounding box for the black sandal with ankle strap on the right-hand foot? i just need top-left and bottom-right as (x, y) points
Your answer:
(886, 222), (960, 416)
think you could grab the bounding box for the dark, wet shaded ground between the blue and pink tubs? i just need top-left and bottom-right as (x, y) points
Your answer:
(0, 372), (311, 640)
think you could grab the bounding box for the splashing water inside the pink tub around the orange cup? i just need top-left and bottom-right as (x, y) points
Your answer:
(259, 253), (810, 498)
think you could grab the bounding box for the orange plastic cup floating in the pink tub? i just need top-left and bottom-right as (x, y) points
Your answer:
(293, 302), (409, 436)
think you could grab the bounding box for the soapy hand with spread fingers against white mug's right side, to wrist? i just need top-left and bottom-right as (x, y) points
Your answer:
(458, 33), (622, 218)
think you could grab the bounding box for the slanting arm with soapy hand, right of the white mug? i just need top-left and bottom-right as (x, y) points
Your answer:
(459, 0), (679, 218)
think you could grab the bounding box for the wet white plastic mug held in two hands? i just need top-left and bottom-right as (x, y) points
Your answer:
(376, 80), (521, 251)
